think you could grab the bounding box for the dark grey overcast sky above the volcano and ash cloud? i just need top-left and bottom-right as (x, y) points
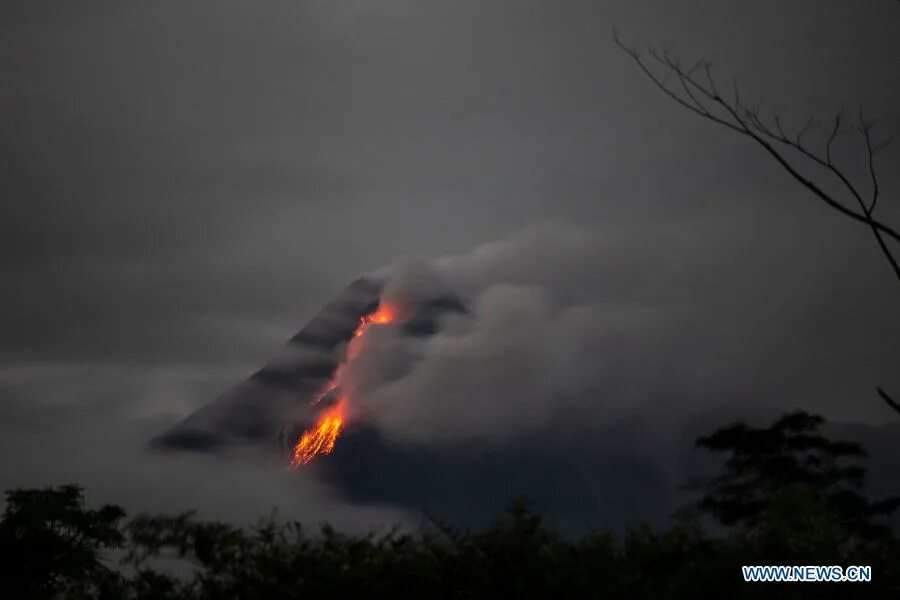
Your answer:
(0, 0), (900, 520)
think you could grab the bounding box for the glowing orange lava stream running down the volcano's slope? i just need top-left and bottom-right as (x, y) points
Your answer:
(291, 306), (396, 469)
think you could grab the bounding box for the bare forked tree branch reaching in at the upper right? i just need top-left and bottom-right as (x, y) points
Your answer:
(613, 30), (900, 281)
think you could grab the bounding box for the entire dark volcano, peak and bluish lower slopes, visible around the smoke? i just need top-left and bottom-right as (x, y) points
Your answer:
(152, 278), (900, 533)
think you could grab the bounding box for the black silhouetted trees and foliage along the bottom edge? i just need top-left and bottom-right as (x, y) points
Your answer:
(0, 413), (900, 600)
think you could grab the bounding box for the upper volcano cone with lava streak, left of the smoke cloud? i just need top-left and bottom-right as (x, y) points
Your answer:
(151, 277), (466, 454)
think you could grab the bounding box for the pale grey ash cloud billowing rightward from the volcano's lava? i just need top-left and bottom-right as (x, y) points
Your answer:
(341, 219), (900, 444)
